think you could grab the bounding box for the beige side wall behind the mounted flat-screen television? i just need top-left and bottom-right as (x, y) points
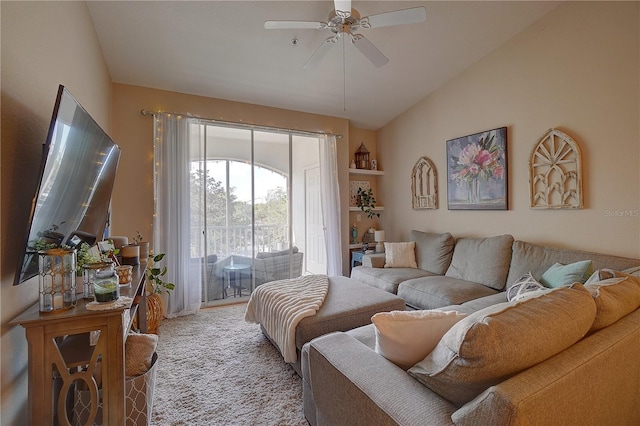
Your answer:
(0, 1), (111, 425)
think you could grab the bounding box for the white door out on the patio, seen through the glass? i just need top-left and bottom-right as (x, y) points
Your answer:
(304, 167), (327, 274)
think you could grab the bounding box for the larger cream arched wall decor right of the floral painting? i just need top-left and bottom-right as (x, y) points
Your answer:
(529, 129), (583, 209)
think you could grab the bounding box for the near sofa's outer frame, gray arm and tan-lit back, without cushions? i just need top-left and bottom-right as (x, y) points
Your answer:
(302, 309), (640, 426)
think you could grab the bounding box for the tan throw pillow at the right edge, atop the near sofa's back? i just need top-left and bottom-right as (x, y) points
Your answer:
(585, 275), (640, 331)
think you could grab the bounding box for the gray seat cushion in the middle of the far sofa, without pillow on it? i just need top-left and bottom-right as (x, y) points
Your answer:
(398, 275), (498, 309)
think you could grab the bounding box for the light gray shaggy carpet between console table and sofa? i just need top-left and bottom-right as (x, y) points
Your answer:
(151, 303), (308, 426)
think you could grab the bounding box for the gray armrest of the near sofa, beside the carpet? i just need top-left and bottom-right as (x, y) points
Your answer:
(303, 332), (456, 426)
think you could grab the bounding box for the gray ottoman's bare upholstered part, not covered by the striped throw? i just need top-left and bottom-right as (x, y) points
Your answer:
(260, 276), (405, 377)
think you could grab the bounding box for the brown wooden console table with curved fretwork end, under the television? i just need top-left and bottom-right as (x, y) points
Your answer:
(11, 264), (147, 425)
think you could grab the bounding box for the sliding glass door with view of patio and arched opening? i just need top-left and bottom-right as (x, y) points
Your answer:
(189, 122), (326, 304)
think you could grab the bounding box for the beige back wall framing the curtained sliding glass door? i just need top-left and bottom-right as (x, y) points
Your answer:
(112, 84), (349, 271)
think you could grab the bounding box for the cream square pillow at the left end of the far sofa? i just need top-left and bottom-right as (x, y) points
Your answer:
(411, 230), (455, 275)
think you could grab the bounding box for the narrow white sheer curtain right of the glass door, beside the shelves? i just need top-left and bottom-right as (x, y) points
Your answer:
(320, 135), (342, 276)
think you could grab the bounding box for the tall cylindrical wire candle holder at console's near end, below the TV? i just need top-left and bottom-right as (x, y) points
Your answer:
(38, 248), (76, 312)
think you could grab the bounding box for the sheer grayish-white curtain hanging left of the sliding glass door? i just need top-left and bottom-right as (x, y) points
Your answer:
(153, 113), (201, 317)
